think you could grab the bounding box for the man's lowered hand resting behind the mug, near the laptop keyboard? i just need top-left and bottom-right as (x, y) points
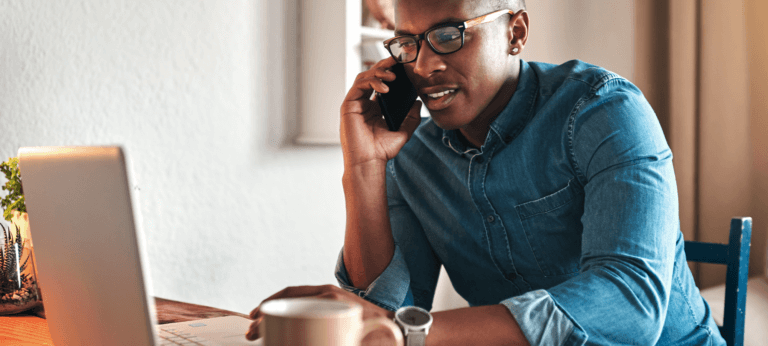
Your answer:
(246, 285), (395, 340)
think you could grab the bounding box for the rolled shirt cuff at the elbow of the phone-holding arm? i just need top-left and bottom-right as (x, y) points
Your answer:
(336, 244), (412, 311)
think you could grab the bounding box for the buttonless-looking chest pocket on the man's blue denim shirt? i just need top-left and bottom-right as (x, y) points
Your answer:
(515, 180), (584, 276)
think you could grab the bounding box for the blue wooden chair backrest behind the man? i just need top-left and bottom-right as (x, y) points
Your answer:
(685, 217), (752, 346)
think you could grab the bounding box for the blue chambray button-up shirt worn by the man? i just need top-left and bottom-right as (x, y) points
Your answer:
(336, 61), (725, 345)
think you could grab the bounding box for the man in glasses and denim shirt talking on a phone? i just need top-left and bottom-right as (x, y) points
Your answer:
(248, 0), (724, 345)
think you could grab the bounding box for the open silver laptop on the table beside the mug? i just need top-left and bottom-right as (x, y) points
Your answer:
(19, 147), (261, 346)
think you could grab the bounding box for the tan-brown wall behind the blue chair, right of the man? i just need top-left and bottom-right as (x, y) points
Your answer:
(635, 0), (768, 287)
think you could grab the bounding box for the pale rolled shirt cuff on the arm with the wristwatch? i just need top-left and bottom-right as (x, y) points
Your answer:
(501, 290), (587, 345)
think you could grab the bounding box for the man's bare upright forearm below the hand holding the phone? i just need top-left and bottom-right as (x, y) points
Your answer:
(342, 162), (395, 289)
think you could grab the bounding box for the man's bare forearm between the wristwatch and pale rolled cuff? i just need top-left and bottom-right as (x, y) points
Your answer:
(427, 304), (529, 346)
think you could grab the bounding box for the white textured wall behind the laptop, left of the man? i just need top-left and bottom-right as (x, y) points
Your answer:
(0, 0), (344, 312)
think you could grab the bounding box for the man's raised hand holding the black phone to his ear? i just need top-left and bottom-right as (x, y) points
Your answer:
(340, 57), (421, 168)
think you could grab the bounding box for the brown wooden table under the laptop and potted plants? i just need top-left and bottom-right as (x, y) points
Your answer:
(0, 298), (249, 345)
